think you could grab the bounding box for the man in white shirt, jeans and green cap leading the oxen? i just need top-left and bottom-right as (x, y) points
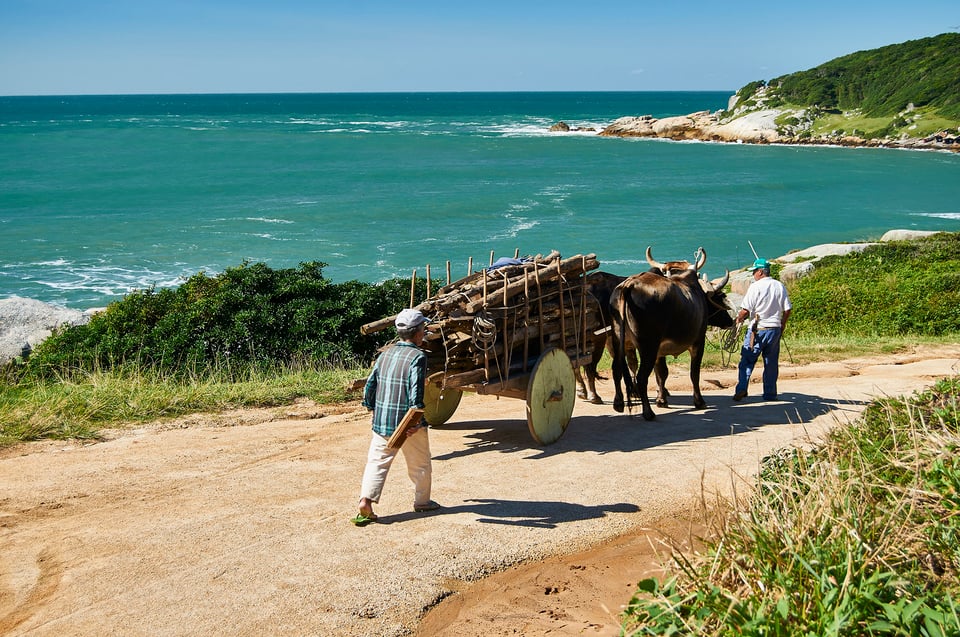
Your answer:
(733, 259), (792, 400)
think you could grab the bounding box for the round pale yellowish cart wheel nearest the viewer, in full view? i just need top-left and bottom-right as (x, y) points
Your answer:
(527, 348), (577, 445)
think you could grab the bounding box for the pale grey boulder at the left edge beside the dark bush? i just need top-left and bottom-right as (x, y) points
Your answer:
(0, 296), (93, 364)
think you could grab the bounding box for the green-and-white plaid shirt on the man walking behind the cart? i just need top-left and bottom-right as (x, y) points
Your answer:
(363, 341), (427, 438)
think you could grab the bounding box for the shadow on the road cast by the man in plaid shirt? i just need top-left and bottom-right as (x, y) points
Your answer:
(379, 498), (640, 529)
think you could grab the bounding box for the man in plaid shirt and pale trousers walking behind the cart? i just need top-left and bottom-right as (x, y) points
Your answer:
(351, 309), (440, 526)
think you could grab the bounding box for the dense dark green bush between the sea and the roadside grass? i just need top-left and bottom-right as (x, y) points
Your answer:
(19, 262), (425, 378)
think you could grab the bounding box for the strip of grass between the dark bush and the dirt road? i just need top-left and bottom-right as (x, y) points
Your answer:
(0, 364), (365, 445)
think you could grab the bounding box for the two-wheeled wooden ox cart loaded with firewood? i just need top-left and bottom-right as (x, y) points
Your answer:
(361, 252), (602, 445)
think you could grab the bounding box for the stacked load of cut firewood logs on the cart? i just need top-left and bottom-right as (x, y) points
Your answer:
(361, 251), (602, 387)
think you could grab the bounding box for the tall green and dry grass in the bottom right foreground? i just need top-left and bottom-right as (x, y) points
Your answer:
(623, 378), (960, 637)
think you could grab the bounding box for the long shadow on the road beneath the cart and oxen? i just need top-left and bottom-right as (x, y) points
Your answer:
(434, 393), (865, 461)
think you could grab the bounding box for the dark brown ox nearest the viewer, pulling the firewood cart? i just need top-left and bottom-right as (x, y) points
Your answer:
(610, 248), (733, 420)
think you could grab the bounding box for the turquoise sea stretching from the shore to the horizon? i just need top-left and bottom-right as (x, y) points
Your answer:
(0, 93), (960, 309)
